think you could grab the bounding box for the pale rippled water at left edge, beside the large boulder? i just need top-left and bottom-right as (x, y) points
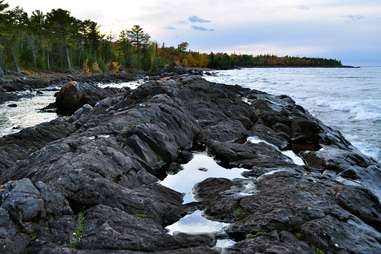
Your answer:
(0, 91), (57, 137)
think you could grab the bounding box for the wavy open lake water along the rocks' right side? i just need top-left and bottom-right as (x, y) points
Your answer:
(206, 67), (381, 161)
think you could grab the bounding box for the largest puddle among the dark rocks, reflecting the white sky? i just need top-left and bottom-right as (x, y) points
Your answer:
(160, 153), (246, 204)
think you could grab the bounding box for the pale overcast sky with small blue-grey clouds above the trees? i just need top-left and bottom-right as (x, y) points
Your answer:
(8, 0), (381, 65)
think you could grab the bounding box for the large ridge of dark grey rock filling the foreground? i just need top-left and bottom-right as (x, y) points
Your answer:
(0, 75), (381, 254)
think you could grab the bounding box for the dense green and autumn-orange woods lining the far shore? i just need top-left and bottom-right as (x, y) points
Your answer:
(0, 0), (341, 77)
